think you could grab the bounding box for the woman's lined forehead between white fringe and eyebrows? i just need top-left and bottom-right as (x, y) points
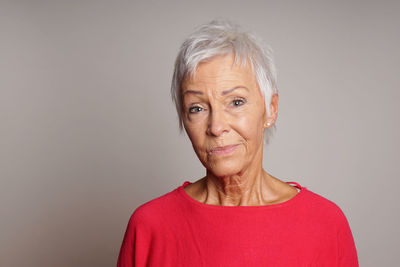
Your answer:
(182, 55), (257, 91)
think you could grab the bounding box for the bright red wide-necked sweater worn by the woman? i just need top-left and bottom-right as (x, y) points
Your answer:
(117, 181), (358, 267)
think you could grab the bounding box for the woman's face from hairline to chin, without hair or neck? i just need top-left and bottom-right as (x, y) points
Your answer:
(182, 56), (278, 177)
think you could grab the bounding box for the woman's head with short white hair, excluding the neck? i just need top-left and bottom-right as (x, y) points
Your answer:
(172, 21), (278, 176)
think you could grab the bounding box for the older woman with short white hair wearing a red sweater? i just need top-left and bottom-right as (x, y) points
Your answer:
(118, 21), (358, 267)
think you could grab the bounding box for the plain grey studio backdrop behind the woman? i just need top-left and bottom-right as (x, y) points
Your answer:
(0, 0), (400, 267)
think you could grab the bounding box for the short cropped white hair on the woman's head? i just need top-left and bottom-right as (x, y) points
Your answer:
(171, 20), (278, 143)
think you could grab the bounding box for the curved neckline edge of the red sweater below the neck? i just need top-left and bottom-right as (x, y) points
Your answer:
(177, 181), (308, 210)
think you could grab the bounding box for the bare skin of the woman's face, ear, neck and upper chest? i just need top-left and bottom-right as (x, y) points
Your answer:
(182, 55), (297, 206)
